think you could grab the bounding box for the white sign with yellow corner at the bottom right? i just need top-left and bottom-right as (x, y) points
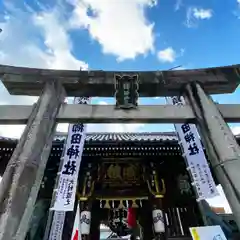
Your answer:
(189, 225), (227, 240)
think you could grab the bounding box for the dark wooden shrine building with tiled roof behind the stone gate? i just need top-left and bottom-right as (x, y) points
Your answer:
(0, 132), (240, 240)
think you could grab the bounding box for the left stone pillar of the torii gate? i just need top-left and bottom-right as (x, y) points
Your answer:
(0, 81), (65, 240)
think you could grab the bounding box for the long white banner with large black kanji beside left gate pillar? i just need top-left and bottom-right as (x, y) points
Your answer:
(51, 97), (90, 212)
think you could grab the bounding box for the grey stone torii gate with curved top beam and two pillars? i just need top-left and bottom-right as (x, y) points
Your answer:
(0, 65), (240, 240)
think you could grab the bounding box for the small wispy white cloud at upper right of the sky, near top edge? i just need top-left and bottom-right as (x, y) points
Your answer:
(185, 7), (213, 28)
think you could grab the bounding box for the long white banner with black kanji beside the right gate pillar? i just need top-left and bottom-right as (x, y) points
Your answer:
(167, 97), (218, 200)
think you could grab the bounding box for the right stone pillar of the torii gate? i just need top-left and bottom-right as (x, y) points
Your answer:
(185, 83), (240, 229)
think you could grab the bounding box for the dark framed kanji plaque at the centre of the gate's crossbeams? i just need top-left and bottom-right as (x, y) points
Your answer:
(115, 75), (138, 109)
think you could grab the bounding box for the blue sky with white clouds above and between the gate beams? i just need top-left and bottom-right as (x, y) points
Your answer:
(0, 0), (240, 210)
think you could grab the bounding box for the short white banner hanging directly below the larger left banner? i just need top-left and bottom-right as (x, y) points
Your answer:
(48, 212), (65, 240)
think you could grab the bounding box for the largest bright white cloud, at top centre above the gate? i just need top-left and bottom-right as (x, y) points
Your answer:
(68, 0), (157, 61)
